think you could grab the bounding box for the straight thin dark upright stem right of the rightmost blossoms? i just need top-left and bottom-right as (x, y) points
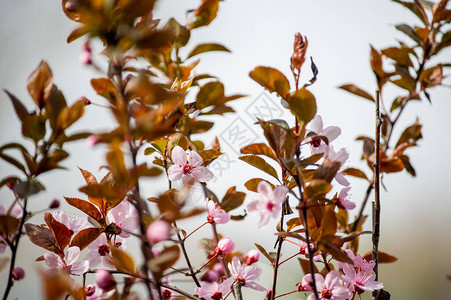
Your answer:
(372, 91), (382, 299)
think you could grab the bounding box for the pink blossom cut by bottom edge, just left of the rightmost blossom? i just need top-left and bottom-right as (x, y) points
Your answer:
(307, 270), (352, 300)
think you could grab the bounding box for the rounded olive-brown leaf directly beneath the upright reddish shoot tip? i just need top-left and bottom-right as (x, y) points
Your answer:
(287, 88), (316, 124)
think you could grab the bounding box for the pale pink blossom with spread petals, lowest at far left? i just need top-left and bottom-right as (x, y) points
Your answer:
(44, 246), (89, 275)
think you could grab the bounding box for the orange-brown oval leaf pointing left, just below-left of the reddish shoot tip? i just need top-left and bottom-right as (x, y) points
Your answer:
(249, 67), (290, 98)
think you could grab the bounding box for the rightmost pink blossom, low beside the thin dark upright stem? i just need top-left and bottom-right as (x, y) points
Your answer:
(338, 249), (384, 295)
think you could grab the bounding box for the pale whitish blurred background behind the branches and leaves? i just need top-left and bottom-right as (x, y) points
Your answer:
(0, 0), (451, 299)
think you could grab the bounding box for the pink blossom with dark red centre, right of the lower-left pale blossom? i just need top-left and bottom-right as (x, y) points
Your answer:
(86, 234), (124, 269)
